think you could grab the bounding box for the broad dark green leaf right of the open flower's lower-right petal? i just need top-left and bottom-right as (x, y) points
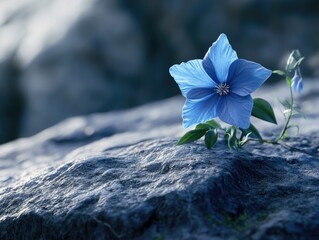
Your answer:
(251, 98), (277, 124)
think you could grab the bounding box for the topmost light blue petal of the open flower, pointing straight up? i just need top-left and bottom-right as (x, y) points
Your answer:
(203, 33), (238, 83)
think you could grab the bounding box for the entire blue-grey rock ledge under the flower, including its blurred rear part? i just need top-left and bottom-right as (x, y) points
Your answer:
(0, 80), (319, 240)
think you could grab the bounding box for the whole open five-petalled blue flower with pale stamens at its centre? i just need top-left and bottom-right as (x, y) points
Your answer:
(169, 34), (272, 129)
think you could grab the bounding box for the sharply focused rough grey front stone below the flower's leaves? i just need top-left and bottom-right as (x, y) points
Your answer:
(0, 139), (319, 239)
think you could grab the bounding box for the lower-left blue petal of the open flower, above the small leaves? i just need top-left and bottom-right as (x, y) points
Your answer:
(182, 94), (220, 128)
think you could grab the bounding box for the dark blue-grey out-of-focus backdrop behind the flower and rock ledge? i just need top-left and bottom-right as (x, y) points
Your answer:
(0, 0), (319, 143)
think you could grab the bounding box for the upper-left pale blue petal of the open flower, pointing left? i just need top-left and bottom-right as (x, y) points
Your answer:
(169, 59), (216, 97)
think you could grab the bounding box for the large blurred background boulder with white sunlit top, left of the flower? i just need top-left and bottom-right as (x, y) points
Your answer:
(0, 0), (155, 138)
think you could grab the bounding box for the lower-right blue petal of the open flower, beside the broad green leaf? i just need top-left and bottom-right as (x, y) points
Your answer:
(217, 93), (254, 129)
